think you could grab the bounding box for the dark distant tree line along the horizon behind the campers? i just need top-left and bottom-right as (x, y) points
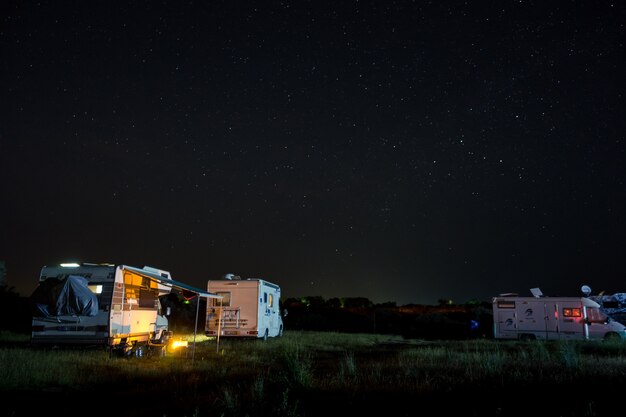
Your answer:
(0, 285), (493, 340)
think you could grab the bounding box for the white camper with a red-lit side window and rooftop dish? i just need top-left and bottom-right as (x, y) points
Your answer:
(492, 295), (626, 340)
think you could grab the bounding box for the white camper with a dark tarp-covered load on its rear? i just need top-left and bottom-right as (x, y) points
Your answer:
(31, 264), (171, 355)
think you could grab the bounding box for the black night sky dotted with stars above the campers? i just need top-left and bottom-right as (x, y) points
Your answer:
(0, 0), (626, 305)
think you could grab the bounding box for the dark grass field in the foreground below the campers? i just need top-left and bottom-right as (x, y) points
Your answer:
(0, 331), (626, 417)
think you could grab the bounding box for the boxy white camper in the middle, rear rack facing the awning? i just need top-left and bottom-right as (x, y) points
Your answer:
(205, 278), (283, 339)
